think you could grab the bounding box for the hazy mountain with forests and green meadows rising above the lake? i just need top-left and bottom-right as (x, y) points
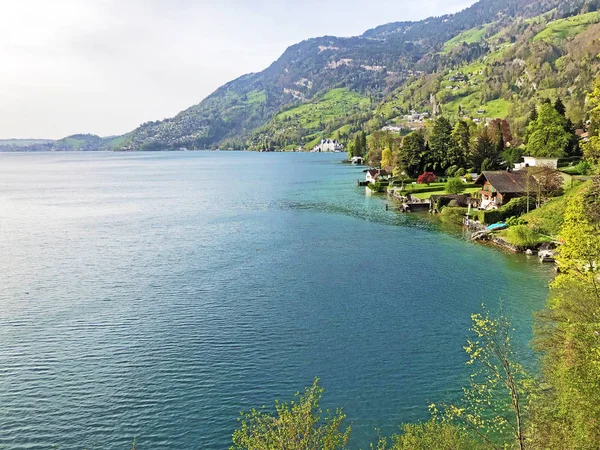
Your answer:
(5, 0), (600, 150)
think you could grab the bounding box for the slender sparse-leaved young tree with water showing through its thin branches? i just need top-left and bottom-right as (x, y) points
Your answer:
(443, 311), (532, 450)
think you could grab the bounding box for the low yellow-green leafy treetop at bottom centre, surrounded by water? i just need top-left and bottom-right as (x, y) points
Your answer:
(231, 380), (350, 450)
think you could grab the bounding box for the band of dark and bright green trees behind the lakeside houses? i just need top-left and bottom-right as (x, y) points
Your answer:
(348, 97), (580, 178)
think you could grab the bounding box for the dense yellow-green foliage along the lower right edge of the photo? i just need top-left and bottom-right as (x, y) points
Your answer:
(531, 181), (600, 450)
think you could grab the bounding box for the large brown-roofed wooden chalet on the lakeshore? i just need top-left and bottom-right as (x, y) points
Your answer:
(475, 171), (535, 209)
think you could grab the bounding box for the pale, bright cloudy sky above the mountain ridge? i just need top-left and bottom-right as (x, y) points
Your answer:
(0, 0), (474, 139)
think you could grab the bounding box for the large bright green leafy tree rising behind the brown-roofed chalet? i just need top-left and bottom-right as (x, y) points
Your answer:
(527, 103), (572, 158)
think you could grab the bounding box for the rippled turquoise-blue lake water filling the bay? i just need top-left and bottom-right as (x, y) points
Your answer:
(0, 152), (550, 449)
